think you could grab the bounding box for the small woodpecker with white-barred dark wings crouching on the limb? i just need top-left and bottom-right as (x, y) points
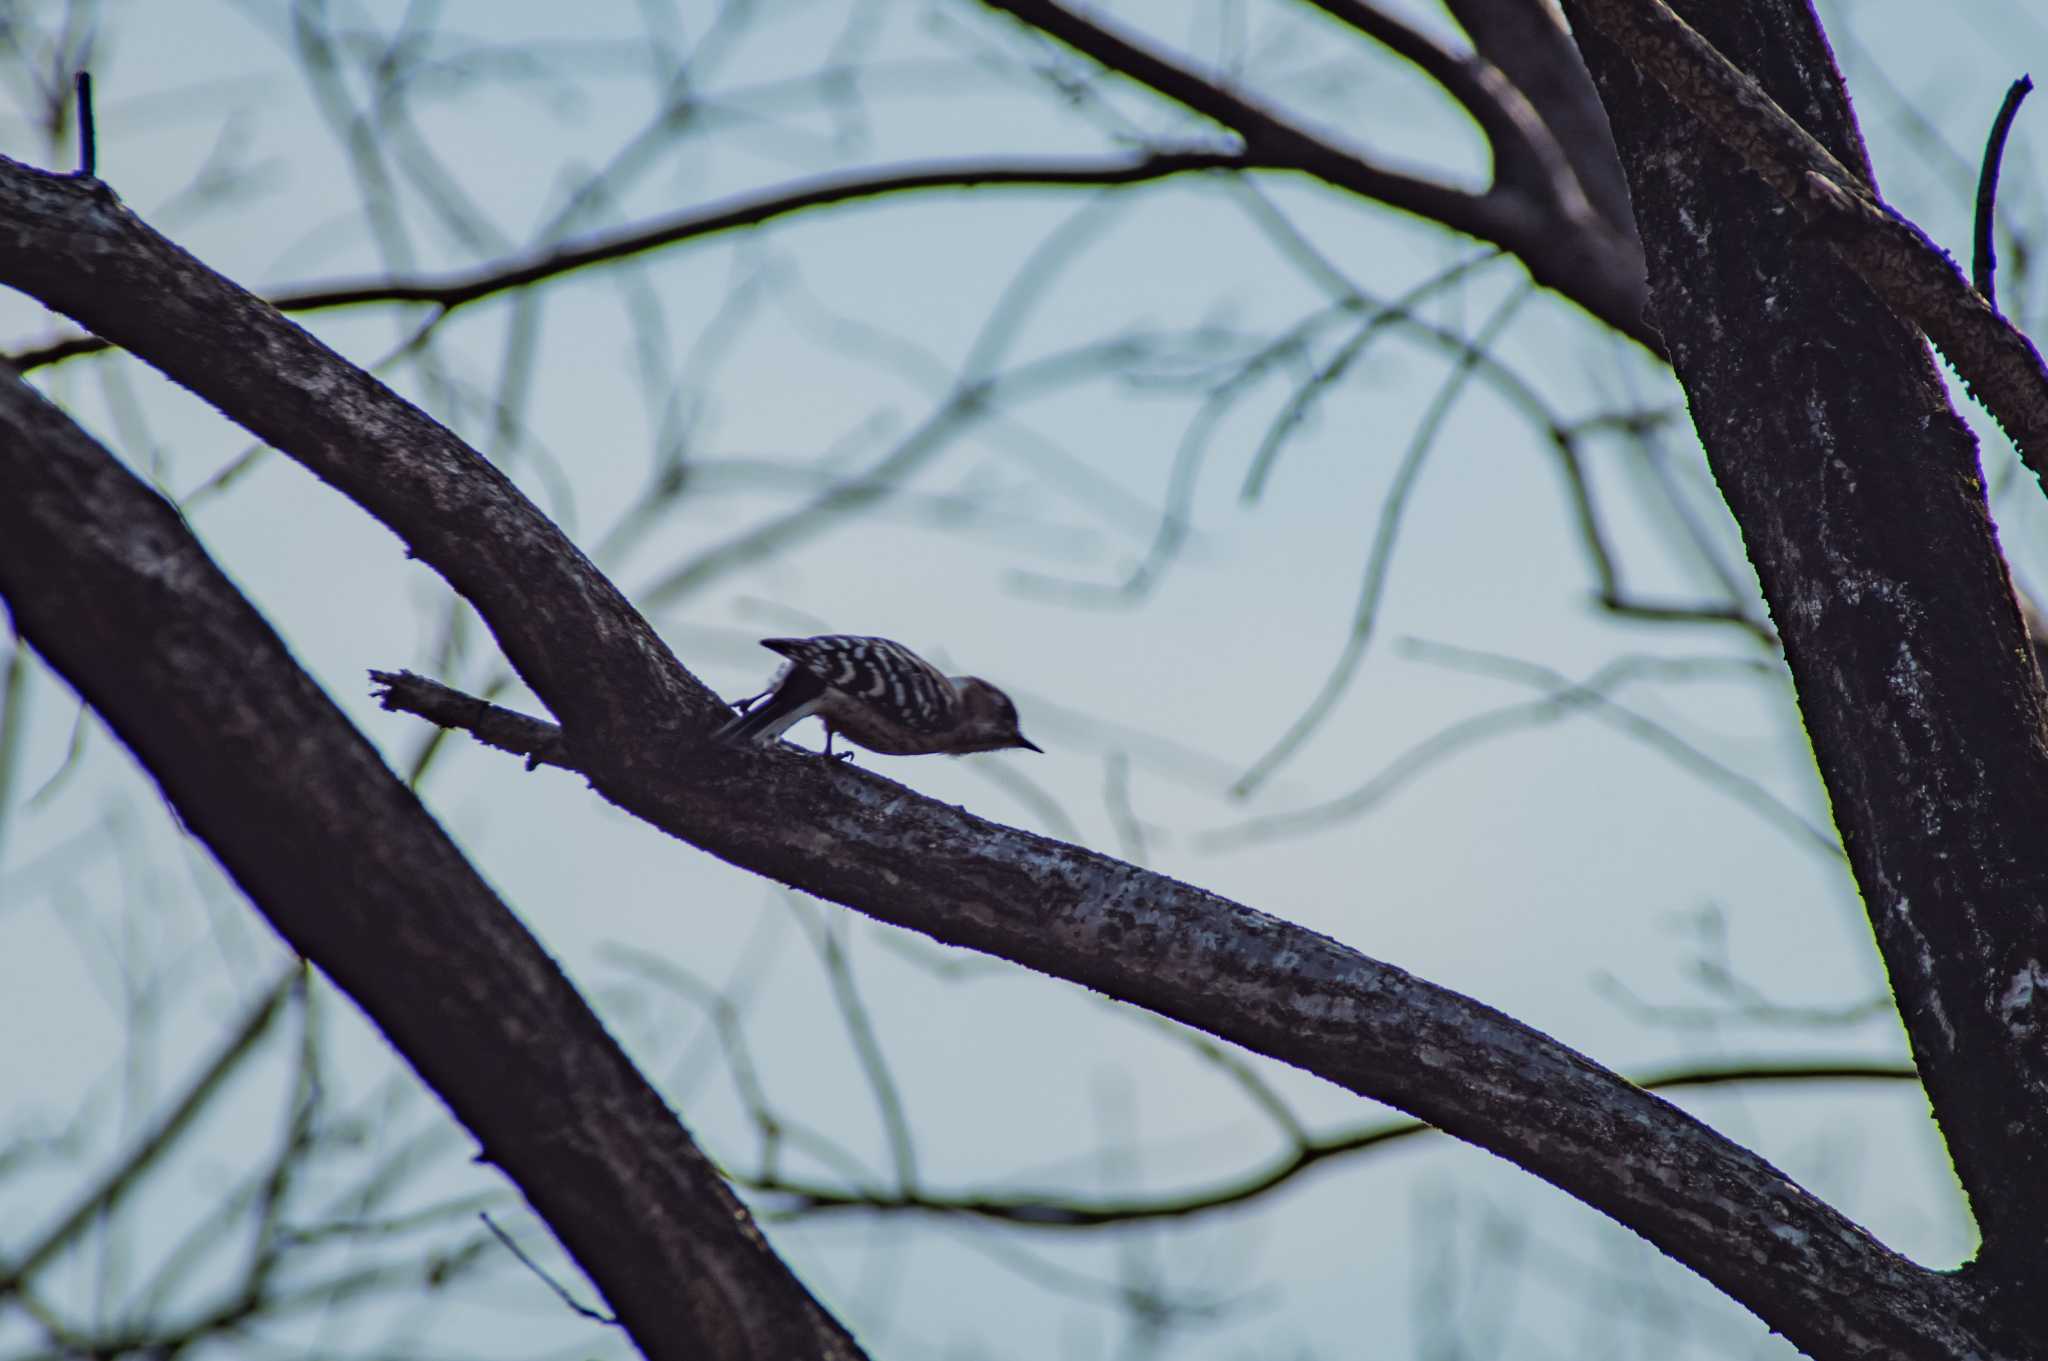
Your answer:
(711, 632), (1040, 755)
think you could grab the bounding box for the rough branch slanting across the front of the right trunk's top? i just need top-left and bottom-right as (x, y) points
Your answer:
(1573, 0), (2048, 476)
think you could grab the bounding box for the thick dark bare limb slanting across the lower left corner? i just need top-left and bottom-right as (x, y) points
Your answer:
(0, 368), (858, 1361)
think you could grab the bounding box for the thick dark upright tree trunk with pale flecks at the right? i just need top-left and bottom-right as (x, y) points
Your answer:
(1567, 0), (2048, 1309)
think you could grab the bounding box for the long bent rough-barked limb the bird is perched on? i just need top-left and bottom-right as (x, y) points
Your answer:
(0, 162), (2019, 1357)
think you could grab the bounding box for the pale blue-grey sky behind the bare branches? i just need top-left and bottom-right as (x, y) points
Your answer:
(0, 0), (2048, 1357)
